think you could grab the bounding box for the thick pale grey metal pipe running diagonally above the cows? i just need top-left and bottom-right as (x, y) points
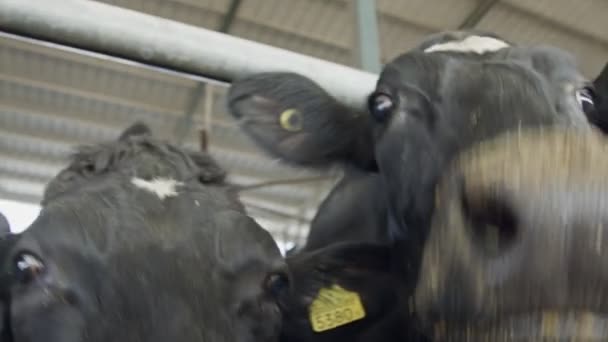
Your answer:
(0, 0), (378, 108)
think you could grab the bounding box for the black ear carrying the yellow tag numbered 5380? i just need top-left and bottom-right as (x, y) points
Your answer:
(280, 242), (412, 342)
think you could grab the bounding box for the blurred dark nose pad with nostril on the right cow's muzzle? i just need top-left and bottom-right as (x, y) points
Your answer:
(460, 170), (608, 292)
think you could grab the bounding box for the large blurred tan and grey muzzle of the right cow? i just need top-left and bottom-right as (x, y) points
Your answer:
(413, 128), (608, 341)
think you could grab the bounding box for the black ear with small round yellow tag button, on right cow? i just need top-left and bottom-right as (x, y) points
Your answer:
(228, 72), (375, 169)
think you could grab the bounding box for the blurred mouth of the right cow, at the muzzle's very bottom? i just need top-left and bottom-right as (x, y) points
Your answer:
(433, 311), (608, 341)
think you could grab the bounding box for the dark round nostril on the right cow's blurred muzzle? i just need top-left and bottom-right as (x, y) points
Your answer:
(462, 190), (518, 257)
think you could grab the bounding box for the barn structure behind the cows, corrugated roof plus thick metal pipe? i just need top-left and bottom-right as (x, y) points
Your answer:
(0, 0), (608, 251)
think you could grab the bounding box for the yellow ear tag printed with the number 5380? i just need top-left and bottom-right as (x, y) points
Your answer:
(309, 285), (365, 332)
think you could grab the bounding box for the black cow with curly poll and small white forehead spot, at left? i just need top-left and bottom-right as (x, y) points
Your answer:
(0, 124), (288, 342)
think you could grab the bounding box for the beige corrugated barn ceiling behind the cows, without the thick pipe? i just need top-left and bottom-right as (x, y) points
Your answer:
(0, 0), (608, 246)
